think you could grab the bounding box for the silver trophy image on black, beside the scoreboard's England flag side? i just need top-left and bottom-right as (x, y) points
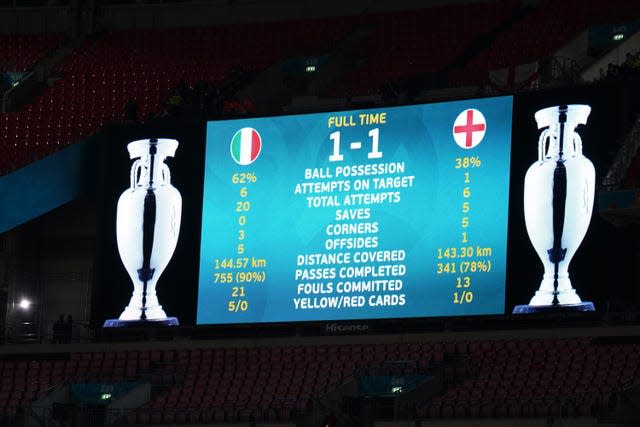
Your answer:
(513, 105), (595, 313)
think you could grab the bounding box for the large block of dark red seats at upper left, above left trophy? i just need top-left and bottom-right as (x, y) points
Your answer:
(0, 18), (356, 173)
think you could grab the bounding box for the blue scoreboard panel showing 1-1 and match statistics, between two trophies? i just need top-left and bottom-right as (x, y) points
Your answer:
(197, 97), (512, 324)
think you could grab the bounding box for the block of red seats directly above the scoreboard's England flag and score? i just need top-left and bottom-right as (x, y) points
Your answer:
(331, 0), (517, 96)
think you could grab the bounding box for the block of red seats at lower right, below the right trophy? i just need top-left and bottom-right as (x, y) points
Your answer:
(421, 340), (638, 417)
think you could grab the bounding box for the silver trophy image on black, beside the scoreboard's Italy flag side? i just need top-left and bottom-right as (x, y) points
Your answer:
(104, 139), (182, 327)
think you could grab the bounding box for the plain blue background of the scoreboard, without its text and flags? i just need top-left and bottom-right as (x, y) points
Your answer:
(197, 97), (512, 324)
